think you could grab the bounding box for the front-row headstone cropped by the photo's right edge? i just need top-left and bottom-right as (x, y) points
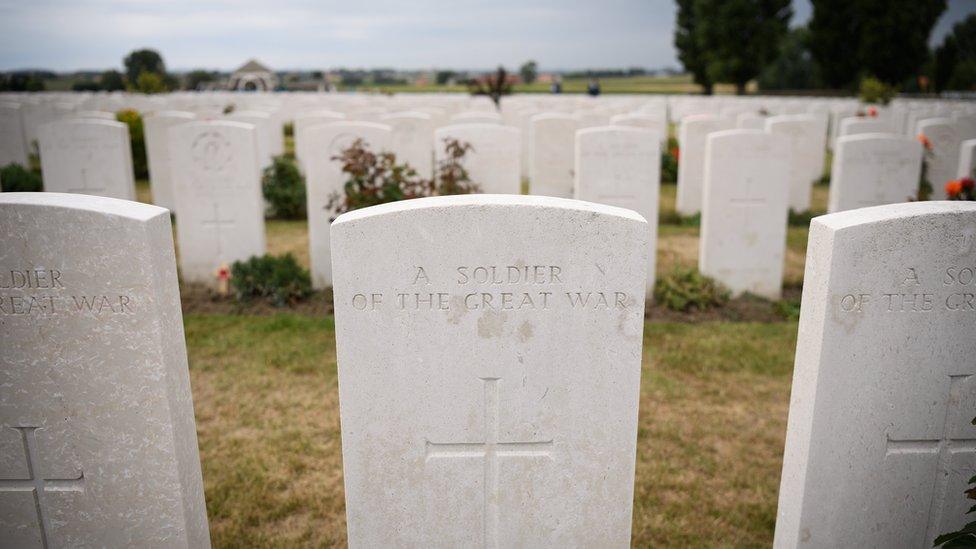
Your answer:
(774, 202), (976, 548)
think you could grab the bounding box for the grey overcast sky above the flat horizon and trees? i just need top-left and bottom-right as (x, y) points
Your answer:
(0, 0), (976, 71)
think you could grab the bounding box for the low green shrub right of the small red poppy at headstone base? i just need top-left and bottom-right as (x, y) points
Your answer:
(230, 254), (312, 307)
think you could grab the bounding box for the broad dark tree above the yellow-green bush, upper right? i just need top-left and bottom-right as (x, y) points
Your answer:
(858, 0), (946, 86)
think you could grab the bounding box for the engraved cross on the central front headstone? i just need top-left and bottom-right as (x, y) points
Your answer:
(426, 377), (552, 547)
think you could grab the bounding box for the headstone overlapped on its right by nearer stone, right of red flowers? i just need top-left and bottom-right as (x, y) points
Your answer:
(675, 114), (735, 215)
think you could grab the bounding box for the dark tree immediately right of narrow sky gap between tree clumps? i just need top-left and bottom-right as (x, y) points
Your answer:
(807, 0), (861, 89)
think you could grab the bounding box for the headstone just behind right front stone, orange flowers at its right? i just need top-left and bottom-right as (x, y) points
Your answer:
(827, 133), (922, 212)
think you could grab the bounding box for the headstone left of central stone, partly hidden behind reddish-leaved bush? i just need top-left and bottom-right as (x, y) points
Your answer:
(305, 122), (393, 289)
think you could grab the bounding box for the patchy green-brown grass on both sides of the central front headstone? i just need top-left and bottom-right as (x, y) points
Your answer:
(184, 314), (796, 547)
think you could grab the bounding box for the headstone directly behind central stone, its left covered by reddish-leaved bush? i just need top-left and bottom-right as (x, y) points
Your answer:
(434, 124), (522, 194)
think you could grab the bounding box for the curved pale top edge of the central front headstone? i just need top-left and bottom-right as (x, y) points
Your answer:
(332, 194), (647, 227)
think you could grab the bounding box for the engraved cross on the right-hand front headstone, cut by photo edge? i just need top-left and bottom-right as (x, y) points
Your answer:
(885, 375), (976, 543)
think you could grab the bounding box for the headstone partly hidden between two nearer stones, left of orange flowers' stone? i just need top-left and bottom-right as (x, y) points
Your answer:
(766, 114), (826, 212)
